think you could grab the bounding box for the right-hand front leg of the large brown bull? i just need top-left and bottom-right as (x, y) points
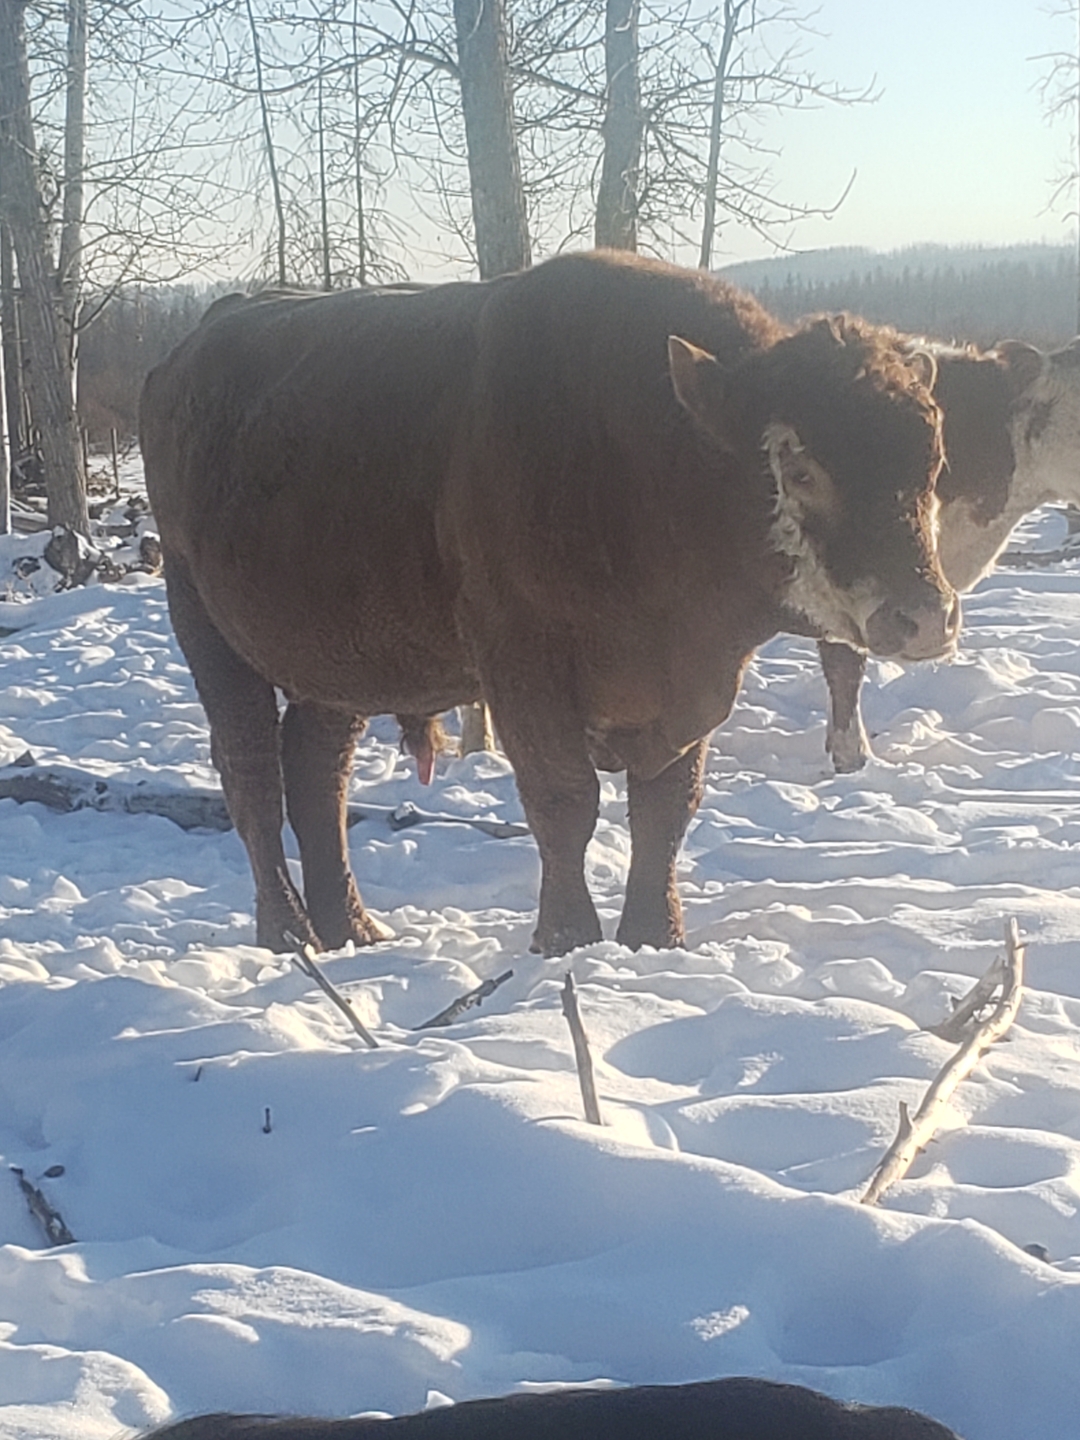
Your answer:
(616, 740), (708, 950)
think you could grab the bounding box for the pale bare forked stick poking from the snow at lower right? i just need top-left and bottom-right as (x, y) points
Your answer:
(863, 920), (1024, 1205)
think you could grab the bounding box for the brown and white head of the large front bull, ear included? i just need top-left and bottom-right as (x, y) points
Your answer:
(668, 317), (960, 660)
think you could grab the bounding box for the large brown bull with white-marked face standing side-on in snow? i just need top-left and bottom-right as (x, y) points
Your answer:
(141, 253), (959, 955)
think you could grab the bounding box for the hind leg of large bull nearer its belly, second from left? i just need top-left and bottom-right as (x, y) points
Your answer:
(281, 701), (392, 950)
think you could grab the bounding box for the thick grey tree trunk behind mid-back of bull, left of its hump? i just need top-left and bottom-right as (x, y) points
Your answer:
(454, 0), (531, 279)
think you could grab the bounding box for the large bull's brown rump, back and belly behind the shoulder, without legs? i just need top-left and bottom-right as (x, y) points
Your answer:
(141, 285), (482, 710)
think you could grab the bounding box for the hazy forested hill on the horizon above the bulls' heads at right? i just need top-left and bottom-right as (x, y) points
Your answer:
(733, 251), (1076, 347)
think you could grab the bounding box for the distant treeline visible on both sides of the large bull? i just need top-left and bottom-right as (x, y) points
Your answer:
(79, 246), (1076, 444)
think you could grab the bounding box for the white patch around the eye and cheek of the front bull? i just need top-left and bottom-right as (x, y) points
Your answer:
(762, 425), (881, 647)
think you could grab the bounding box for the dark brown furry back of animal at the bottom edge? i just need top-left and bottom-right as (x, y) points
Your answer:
(137, 1377), (959, 1440)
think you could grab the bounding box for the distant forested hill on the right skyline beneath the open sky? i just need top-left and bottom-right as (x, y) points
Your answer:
(720, 245), (1076, 346)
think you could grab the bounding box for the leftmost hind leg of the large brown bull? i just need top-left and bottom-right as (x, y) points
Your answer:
(166, 553), (317, 950)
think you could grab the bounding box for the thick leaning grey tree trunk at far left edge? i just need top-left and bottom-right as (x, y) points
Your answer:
(0, 0), (89, 534)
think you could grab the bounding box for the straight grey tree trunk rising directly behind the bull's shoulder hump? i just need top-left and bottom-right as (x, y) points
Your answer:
(595, 0), (644, 251)
